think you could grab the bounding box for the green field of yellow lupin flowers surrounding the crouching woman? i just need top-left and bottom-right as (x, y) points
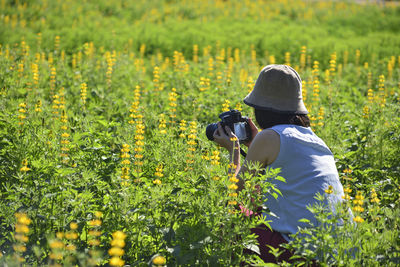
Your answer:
(0, 0), (400, 266)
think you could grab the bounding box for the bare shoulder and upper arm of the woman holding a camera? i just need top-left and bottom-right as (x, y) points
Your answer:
(246, 129), (280, 166)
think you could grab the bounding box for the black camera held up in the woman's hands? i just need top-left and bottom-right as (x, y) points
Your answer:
(206, 109), (251, 142)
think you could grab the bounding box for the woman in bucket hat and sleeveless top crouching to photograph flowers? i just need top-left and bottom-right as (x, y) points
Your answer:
(214, 65), (344, 262)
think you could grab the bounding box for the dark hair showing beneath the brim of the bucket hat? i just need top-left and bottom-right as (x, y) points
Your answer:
(254, 109), (310, 129)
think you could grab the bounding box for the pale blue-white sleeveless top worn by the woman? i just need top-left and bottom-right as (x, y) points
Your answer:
(264, 125), (344, 239)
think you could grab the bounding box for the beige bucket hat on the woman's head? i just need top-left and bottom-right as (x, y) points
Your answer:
(243, 65), (308, 114)
